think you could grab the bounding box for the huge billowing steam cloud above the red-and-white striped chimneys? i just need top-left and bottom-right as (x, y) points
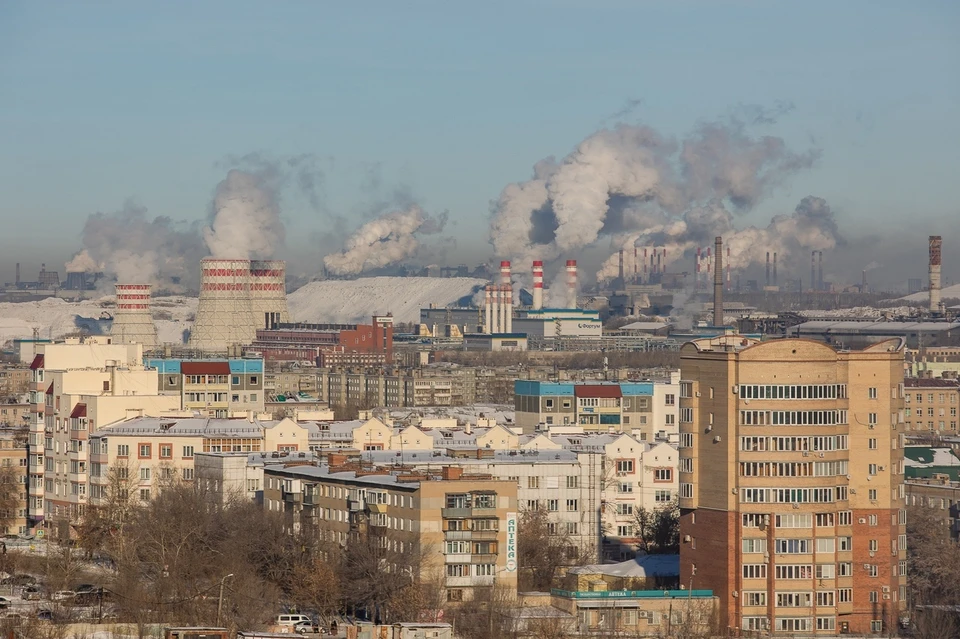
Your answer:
(491, 116), (841, 278)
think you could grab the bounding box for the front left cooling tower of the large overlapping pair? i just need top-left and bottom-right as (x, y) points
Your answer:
(190, 258), (259, 351)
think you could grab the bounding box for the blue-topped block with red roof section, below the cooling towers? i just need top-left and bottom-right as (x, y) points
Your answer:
(147, 358), (265, 418)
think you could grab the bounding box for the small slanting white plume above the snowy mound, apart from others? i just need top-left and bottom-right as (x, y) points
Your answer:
(323, 206), (447, 275)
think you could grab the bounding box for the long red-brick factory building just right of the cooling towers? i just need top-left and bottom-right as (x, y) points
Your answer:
(251, 315), (393, 367)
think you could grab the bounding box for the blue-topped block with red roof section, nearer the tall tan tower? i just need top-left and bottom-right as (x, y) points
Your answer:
(514, 378), (679, 441)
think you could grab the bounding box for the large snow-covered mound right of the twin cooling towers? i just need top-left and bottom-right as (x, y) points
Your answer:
(287, 277), (487, 324)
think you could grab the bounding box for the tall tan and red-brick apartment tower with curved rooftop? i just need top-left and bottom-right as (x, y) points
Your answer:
(679, 335), (906, 635)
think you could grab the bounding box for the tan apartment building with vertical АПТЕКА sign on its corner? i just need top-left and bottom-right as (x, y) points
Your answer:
(263, 459), (518, 602)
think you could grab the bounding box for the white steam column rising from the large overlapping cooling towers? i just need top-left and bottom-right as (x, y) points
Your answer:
(203, 169), (286, 259)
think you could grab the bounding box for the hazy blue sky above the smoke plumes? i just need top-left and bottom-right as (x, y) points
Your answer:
(0, 0), (960, 288)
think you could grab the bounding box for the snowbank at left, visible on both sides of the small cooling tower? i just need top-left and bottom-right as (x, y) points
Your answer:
(0, 296), (197, 344)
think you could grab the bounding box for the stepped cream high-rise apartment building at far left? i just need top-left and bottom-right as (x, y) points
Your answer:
(29, 338), (180, 534)
